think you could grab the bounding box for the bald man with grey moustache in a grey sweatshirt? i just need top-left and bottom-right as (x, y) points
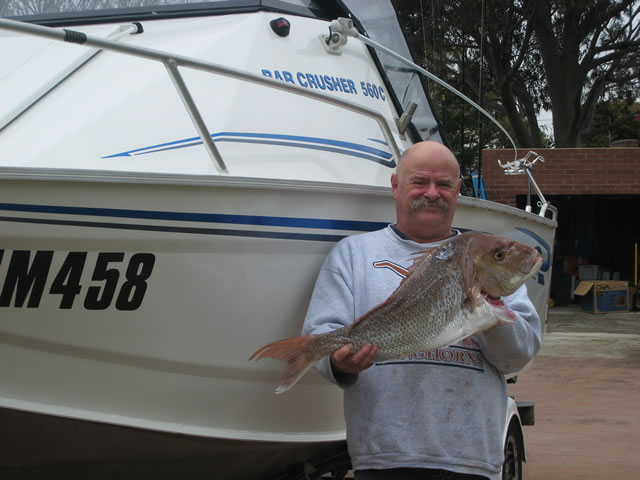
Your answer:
(302, 142), (541, 480)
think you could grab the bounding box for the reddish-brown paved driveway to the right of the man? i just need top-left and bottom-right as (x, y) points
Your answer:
(509, 306), (640, 480)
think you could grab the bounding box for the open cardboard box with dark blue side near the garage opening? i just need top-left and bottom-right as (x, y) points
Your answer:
(573, 280), (629, 313)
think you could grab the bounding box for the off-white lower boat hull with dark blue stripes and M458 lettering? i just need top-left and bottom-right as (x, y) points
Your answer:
(0, 172), (553, 442)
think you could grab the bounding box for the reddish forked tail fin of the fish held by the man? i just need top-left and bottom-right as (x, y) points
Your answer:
(249, 335), (317, 393)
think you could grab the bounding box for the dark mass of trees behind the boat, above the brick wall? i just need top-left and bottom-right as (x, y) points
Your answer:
(395, 0), (640, 147)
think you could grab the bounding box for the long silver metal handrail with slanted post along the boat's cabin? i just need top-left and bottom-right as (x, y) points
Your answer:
(0, 18), (400, 173)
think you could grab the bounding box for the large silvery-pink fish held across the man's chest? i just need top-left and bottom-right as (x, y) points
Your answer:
(250, 232), (542, 393)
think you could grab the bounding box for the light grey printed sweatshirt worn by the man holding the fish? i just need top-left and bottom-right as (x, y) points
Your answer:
(302, 227), (541, 480)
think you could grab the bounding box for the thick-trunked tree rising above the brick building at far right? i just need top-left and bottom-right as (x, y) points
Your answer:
(526, 0), (640, 147)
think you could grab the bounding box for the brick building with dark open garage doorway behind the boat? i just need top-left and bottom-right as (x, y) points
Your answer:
(482, 147), (640, 305)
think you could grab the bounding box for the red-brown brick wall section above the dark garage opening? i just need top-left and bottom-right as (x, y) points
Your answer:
(482, 148), (640, 206)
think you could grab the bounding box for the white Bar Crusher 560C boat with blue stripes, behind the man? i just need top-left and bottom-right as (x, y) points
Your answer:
(0, 0), (556, 479)
